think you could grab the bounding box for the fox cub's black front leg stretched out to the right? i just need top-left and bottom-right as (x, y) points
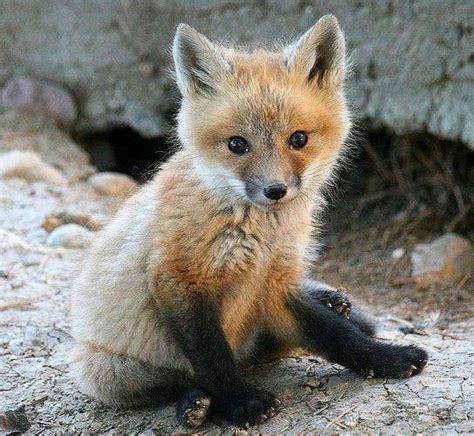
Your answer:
(287, 292), (428, 378)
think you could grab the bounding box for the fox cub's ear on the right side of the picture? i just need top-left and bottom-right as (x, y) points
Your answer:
(284, 15), (346, 88)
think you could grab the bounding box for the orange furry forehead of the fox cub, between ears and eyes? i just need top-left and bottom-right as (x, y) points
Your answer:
(206, 66), (332, 139)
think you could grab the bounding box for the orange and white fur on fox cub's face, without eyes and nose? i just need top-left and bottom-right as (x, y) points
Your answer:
(178, 18), (350, 213)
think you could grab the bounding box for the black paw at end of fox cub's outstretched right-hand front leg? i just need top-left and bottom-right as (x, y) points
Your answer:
(361, 345), (428, 378)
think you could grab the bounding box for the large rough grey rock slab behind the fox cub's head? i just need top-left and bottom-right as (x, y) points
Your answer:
(0, 0), (474, 149)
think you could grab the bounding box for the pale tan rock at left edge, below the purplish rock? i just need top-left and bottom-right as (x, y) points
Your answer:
(0, 150), (68, 186)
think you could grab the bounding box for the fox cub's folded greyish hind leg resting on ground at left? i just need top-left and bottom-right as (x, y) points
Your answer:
(71, 344), (192, 408)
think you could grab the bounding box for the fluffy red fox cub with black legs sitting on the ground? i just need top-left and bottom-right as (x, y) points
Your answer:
(72, 15), (427, 427)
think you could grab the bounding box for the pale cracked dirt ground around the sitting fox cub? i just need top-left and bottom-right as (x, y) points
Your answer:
(0, 117), (474, 434)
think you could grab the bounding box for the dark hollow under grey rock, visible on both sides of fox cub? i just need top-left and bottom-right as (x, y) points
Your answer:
(80, 124), (474, 240)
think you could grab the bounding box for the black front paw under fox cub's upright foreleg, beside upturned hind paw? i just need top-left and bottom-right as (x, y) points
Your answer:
(216, 385), (279, 427)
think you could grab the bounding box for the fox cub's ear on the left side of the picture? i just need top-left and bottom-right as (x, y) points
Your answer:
(173, 24), (231, 97)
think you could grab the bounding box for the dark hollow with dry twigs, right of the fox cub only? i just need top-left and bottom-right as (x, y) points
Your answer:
(328, 130), (474, 240)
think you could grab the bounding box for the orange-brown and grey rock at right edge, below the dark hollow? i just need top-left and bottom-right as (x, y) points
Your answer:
(411, 233), (474, 284)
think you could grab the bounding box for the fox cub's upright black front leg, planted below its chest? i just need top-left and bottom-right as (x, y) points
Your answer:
(158, 282), (276, 425)
